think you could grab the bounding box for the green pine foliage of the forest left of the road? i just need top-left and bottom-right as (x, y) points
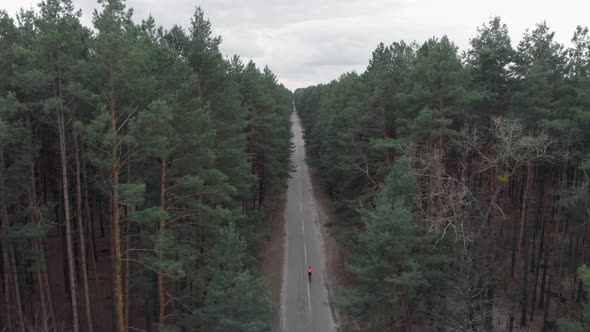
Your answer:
(0, 0), (292, 331)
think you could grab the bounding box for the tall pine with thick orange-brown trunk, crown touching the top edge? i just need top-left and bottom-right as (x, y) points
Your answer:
(86, 0), (154, 332)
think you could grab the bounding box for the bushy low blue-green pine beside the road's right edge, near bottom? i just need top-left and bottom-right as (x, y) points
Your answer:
(341, 159), (453, 331)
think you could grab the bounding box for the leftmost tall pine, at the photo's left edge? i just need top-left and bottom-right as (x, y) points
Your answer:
(3, 11), (61, 328)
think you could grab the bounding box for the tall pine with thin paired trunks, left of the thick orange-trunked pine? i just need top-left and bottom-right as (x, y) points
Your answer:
(36, 0), (93, 331)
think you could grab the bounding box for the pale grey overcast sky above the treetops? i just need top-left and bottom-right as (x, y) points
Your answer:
(0, 0), (590, 90)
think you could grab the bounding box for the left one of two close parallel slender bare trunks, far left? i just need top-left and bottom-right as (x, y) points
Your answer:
(57, 106), (80, 332)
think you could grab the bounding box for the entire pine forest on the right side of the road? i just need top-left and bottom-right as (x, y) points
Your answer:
(295, 17), (590, 331)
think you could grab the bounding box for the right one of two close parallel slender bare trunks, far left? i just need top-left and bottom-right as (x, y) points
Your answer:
(74, 130), (93, 332)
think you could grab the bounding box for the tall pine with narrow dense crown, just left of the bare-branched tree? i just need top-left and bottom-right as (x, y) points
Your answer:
(410, 36), (475, 223)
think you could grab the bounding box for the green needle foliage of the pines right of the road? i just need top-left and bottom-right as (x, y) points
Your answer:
(295, 17), (590, 330)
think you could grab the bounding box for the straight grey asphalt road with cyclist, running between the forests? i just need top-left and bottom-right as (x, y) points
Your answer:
(281, 112), (334, 332)
